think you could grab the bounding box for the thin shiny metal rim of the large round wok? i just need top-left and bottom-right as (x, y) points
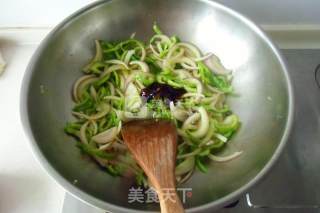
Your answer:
(20, 0), (294, 213)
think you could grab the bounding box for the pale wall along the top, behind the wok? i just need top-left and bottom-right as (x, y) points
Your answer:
(0, 0), (320, 27)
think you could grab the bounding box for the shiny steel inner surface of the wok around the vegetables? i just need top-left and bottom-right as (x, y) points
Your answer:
(21, 0), (293, 212)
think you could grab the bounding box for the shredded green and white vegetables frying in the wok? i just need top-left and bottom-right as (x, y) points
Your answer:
(65, 25), (242, 186)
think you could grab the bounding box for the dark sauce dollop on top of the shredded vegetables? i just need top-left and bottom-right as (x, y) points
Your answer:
(140, 82), (187, 103)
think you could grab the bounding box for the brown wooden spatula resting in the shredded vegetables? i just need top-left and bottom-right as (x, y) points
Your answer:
(121, 120), (184, 213)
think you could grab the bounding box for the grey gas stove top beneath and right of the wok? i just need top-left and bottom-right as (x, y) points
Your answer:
(63, 49), (320, 213)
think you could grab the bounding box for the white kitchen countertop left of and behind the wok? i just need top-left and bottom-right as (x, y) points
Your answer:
(0, 26), (320, 213)
